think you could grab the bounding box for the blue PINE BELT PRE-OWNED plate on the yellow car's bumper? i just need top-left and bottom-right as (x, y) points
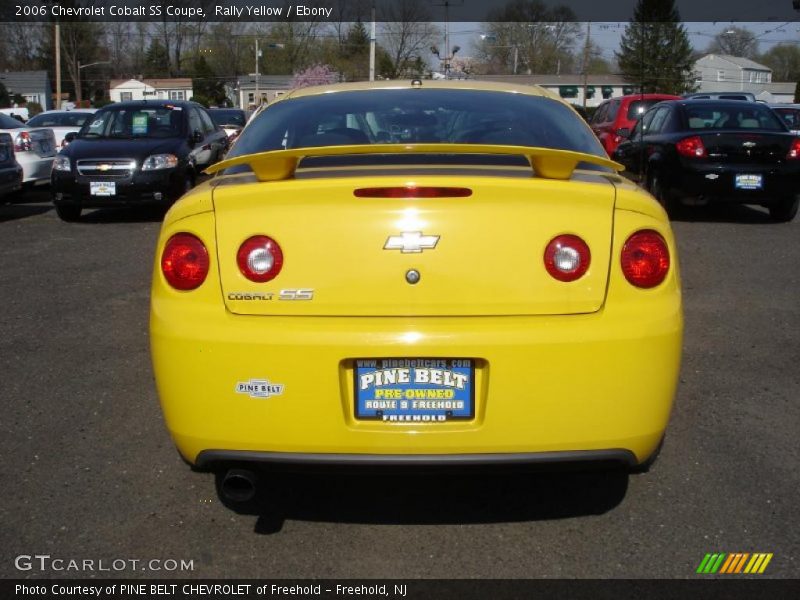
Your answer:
(353, 358), (475, 423)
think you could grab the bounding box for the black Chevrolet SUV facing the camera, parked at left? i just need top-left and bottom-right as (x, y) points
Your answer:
(51, 100), (228, 221)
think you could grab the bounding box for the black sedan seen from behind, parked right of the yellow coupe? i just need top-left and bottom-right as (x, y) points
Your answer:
(614, 100), (800, 221)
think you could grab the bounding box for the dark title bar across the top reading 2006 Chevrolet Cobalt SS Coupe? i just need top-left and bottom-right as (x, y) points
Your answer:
(0, 0), (800, 23)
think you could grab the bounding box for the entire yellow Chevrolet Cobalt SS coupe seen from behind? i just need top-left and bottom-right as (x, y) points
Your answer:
(150, 80), (683, 499)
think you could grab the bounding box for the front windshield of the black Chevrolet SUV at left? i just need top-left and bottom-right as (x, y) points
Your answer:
(78, 106), (183, 138)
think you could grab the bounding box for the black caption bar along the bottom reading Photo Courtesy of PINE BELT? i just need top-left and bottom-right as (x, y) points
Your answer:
(0, 576), (800, 600)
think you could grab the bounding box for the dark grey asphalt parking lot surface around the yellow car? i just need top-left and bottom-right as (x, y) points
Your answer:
(0, 190), (800, 578)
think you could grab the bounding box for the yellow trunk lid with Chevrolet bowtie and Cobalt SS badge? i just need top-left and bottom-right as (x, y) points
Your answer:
(213, 169), (615, 316)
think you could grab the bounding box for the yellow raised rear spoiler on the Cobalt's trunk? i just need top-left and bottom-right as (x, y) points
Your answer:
(205, 144), (624, 181)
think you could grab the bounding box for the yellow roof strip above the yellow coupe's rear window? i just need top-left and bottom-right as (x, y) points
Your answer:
(270, 79), (563, 104)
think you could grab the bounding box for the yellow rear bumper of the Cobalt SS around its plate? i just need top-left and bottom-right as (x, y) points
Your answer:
(151, 302), (682, 464)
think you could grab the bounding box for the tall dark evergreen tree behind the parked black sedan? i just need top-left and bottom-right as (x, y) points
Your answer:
(616, 0), (694, 94)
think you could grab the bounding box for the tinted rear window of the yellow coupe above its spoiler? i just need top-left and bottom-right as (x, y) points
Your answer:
(228, 89), (605, 158)
